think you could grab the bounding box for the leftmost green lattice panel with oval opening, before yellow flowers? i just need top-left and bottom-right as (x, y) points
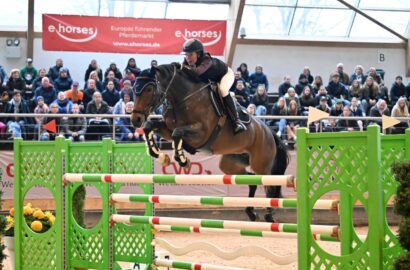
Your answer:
(14, 139), (63, 270)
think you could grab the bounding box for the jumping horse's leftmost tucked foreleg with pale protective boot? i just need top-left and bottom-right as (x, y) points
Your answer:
(144, 121), (171, 166)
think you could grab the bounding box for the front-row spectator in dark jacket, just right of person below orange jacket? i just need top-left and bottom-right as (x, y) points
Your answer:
(86, 91), (111, 139)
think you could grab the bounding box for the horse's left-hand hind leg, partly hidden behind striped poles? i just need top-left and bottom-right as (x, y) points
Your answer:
(219, 154), (259, 221)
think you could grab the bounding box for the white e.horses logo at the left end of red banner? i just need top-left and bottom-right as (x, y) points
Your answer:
(48, 23), (98, 42)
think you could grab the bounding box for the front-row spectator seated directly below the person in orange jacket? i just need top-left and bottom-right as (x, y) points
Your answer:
(63, 104), (87, 142)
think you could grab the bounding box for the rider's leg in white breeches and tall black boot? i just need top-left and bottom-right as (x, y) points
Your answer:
(218, 67), (246, 134)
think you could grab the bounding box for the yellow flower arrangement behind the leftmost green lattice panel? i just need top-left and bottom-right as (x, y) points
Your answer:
(3, 203), (56, 236)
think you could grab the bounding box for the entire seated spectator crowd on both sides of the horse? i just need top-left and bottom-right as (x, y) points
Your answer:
(0, 58), (410, 141)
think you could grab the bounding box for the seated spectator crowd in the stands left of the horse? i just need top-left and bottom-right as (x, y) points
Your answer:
(0, 58), (151, 141)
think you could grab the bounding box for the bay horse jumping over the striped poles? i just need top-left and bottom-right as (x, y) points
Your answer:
(131, 63), (289, 222)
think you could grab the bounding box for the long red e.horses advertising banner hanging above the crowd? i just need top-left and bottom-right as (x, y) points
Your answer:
(43, 14), (226, 56)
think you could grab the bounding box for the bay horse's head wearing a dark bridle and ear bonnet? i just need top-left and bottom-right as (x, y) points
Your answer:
(131, 68), (161, 127)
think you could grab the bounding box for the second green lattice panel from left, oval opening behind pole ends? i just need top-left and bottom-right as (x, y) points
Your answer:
(65, 140), (112, 270)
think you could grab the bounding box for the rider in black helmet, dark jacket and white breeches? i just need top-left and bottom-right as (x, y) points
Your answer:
(182, 39), (246, 134)
